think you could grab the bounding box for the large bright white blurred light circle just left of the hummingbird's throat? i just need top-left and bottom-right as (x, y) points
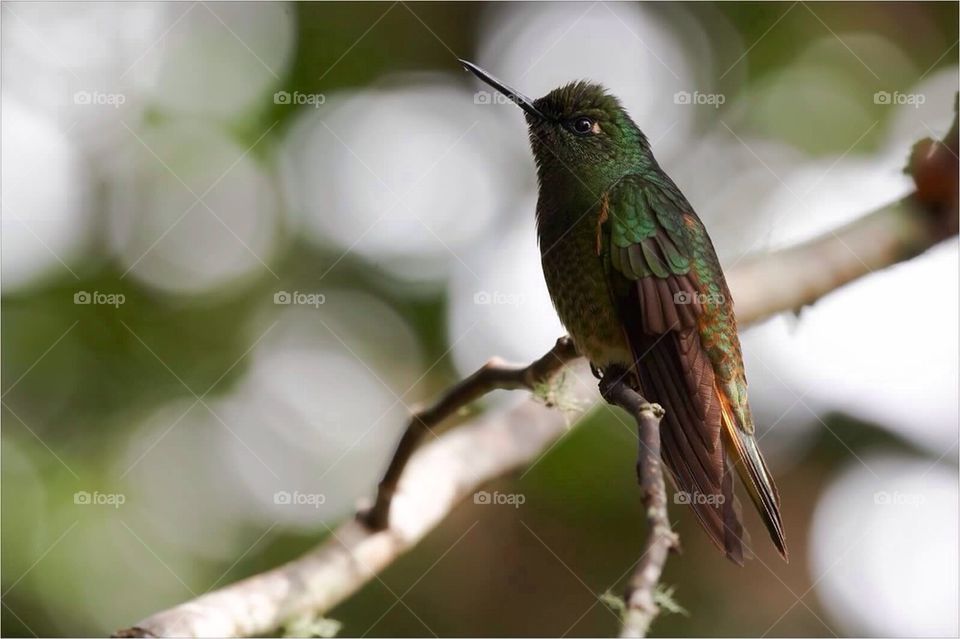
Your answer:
(281, 75), (522, 282)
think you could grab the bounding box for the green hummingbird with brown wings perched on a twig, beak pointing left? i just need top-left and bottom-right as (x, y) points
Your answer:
(460, 60), (787, 565)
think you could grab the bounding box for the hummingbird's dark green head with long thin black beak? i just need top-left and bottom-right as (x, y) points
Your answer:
(461, 60), (652, 190)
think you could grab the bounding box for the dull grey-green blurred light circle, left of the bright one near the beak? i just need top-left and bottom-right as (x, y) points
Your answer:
(108, 121), (280, 295)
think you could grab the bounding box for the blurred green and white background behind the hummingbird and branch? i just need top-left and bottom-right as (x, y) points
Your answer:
(0, 2), (958, 636)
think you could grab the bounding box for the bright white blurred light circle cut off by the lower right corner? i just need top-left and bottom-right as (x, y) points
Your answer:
(810, 456), (958, 637)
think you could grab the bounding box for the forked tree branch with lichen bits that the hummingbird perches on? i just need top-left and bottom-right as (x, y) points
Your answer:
(118, 101), (958, 637)
